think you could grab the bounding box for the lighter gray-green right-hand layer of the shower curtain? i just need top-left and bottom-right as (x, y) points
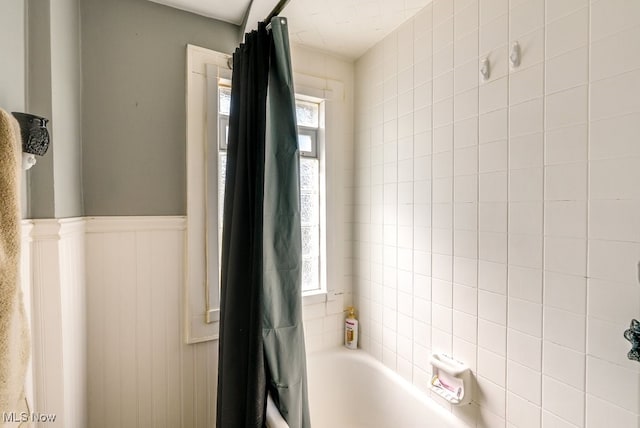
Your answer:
(262, 17), (310, 428)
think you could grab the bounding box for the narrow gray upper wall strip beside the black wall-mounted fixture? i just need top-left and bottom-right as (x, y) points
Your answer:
(27, 0), (83, 218)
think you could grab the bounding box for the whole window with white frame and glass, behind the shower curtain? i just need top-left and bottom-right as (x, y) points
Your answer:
(188, 45), (342, 343)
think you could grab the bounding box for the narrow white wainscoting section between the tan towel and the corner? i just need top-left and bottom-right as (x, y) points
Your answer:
(28, 219), (88, 428)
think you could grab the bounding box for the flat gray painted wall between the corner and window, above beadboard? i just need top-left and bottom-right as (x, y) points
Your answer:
(81, 0), (239, 216)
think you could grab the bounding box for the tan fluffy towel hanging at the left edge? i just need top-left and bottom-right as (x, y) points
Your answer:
(0, 109), (30, 426)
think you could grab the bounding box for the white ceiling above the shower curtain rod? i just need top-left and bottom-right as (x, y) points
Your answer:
(151, 0), (431, 59)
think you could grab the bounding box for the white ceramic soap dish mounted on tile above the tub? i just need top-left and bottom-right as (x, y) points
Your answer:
(431, 354), (471, 405)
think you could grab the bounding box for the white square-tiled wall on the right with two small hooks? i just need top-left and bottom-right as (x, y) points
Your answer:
(354, 0), (640, 428)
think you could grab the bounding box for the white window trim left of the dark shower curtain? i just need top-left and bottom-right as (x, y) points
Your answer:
(184, 45), (231, 343)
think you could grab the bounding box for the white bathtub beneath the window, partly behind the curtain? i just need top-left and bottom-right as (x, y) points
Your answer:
(267, 348), (465, 428)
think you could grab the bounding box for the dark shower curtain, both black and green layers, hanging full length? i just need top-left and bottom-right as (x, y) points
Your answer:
(216, 17), (310, 428)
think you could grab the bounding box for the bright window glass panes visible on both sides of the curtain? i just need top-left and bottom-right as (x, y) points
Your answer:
(217, 81), (322, 292)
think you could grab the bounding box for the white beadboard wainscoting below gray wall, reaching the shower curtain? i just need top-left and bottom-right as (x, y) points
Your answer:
(86, 217), (218, 428)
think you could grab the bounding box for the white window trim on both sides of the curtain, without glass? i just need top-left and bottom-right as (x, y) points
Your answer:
(183, 45), (344, 343)
